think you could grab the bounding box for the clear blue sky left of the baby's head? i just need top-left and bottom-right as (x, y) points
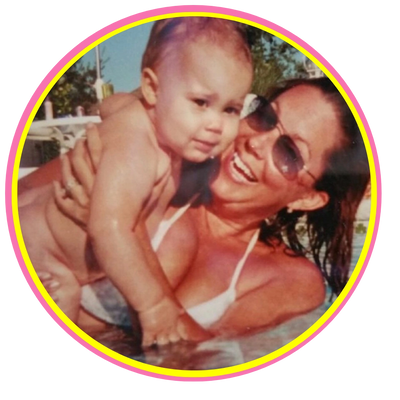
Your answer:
(82, 22), (153, 92)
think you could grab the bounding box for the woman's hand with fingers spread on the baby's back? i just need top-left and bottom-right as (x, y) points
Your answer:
(54, 124), (102, 229)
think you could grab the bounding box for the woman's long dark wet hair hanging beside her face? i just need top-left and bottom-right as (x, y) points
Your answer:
(261, 78), (370, 295)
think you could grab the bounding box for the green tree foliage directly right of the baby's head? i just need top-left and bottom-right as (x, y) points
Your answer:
(246, 26), (307, 95)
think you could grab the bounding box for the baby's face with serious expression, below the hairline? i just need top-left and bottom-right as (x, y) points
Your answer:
(155, 42), (252, 162)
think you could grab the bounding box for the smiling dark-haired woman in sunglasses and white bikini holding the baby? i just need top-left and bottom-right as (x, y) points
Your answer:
(23, 78), (369, 344)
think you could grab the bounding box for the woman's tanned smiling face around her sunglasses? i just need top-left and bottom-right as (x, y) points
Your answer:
(211, 85), (341, 217)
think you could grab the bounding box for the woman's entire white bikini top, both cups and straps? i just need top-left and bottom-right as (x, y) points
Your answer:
(81, 200), (260, 328)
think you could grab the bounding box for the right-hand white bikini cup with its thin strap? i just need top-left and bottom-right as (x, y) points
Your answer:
(186, 230), (260, 328)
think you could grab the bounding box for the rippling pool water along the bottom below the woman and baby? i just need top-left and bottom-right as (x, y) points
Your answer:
(88, 232), (365, 370)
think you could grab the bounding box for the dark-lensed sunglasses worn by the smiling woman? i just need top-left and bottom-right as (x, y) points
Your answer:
(246, 96), (317, 181)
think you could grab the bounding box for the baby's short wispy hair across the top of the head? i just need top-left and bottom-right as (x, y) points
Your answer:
(142, 17), (252, 70)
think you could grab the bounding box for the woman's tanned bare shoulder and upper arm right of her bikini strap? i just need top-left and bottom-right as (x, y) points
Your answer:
(209, 243), (325, 333)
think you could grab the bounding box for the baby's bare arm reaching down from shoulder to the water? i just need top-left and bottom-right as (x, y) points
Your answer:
(88, 108), (184, 341)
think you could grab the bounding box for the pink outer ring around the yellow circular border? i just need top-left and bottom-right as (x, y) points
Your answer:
(3, 3), (383, 384)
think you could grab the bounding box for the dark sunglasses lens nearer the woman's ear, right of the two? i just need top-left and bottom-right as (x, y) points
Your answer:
(273, 135), (304, 180)
